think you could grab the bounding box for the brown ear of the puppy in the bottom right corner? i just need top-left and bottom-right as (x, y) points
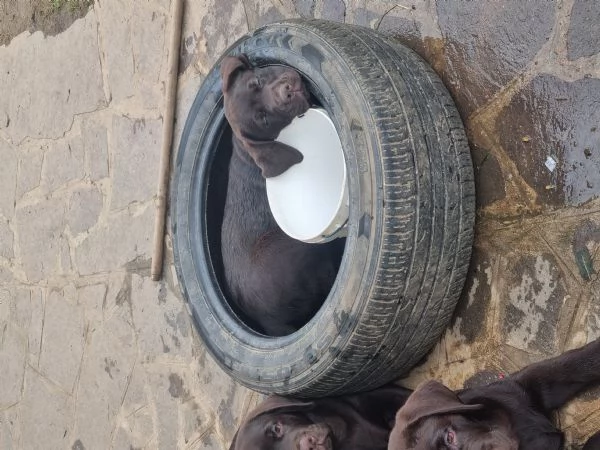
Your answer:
(396, 381), (483, 430)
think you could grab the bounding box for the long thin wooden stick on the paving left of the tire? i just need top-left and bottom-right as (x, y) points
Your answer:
(150, 0), (183, 281)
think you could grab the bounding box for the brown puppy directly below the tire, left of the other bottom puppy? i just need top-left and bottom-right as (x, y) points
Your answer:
(230, 385), (411, 450)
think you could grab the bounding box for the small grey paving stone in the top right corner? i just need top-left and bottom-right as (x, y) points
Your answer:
(567, 0), (600, 60)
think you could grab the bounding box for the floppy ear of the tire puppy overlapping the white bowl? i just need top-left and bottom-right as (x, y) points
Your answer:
(244, 140), (303, 178)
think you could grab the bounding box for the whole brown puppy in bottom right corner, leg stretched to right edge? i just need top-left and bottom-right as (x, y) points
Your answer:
(389, 340), (600, 450)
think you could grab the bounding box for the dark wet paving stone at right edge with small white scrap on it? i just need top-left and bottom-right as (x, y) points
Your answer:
(497, 75), (600, 206)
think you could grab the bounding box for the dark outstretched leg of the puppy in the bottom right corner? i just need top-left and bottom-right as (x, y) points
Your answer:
(513, 339), (600, 411)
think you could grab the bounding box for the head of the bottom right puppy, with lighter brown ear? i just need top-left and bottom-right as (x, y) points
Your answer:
(388, 381), (519, 450)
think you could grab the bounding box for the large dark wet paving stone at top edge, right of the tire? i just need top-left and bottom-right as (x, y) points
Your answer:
(437, 0), (555, 118)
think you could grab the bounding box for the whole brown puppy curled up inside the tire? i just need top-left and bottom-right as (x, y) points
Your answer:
(221, 55), (344, 336)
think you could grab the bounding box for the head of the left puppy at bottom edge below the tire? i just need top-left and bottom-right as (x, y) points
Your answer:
(229, 395), (335, 450)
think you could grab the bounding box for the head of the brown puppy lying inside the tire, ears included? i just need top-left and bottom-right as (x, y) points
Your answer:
(221, 55), (310, 178)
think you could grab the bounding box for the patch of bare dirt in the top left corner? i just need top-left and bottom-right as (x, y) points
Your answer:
(0, 0), (94, 45)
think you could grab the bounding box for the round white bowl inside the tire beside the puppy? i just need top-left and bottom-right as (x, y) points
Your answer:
(267, 108), (348, 243)
